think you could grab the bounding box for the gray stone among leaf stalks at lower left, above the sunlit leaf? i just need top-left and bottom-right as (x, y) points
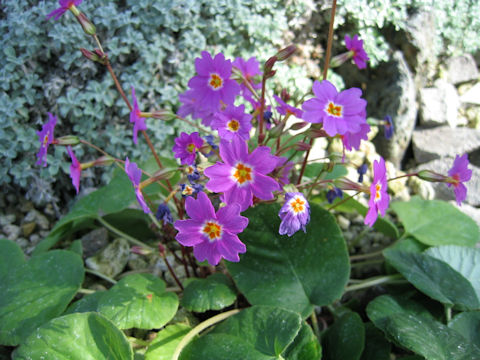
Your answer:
(85, 238), (130, 278)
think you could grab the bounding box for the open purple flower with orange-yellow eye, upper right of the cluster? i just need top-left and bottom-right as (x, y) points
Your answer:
(302, 80), (367, 136)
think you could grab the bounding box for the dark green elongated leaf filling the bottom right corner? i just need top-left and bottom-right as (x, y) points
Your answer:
(367, 295), (480, 360)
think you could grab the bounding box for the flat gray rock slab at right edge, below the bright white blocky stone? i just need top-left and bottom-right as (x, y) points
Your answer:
(412, 126), (480, 164)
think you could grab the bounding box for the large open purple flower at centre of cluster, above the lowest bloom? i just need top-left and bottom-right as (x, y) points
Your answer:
(204, 137), (280, 211)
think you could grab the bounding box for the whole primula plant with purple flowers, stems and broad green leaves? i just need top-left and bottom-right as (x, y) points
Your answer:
(0, 0), (480, 360)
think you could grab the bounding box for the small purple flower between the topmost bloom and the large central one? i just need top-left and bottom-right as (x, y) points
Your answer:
(211, 105), (252, 141)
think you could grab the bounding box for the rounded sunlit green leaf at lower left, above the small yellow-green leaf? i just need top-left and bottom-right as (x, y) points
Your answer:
(98, 274), (178, 329)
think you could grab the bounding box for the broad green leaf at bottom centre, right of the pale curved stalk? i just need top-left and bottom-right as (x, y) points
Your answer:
(180, 306), (302, 360)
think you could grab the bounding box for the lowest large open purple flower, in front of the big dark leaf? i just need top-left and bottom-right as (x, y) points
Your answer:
(174, 192), (248, 265)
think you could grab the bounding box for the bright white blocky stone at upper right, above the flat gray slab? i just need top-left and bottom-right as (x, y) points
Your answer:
(419, 79), (461, 128)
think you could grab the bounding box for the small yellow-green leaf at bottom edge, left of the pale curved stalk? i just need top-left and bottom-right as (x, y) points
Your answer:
(145, 324), (191, 360)
